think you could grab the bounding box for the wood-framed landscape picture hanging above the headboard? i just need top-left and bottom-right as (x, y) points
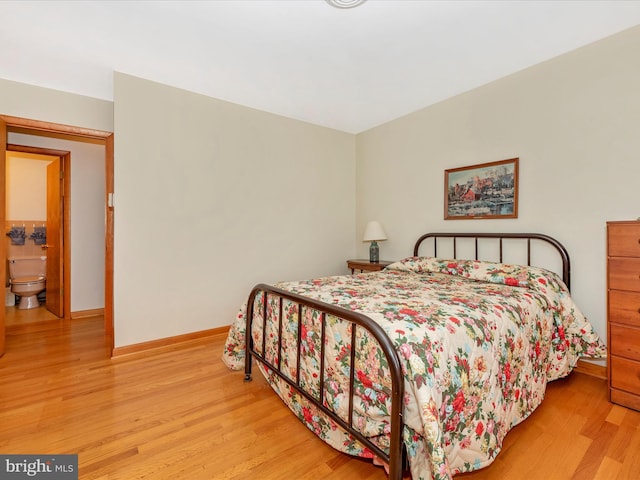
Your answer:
(444, 158), (518, 220)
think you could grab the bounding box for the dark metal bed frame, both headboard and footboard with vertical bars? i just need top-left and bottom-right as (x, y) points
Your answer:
(245, 233), (570, 480)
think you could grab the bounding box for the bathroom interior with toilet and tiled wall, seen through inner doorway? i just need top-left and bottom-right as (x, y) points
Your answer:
(5, 151), (61, 326)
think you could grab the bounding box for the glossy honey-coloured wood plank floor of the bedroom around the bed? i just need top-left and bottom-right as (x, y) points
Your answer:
(0, 317), (640, 480)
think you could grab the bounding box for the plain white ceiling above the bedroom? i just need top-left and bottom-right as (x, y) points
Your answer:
(0, 0), (640, 133)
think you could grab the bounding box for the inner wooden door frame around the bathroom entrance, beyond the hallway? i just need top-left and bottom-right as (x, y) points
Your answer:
(6, 143), (71, 320)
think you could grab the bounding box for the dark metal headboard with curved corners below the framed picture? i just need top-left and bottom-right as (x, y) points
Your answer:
(413, 232), (571, 289)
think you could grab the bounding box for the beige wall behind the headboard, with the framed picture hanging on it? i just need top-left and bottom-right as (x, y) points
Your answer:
(356, 27), (640, 344)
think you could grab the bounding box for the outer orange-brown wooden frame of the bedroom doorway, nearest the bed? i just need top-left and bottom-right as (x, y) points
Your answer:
(0, 115), (114, 355)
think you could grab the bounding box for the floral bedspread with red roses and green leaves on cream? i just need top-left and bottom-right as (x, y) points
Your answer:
(223, 257), (606, 480)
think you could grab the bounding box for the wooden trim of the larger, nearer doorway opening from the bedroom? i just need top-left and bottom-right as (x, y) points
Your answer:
(0, 114), (114, 356)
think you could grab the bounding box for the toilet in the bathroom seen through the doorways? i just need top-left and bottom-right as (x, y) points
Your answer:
(8, 256), (47, 309)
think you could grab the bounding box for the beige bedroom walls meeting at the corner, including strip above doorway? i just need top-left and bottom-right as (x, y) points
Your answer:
(0, 28), (640, 346)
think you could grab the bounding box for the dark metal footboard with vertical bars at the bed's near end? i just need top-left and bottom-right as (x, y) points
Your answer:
(245, 284), (404, 480)
